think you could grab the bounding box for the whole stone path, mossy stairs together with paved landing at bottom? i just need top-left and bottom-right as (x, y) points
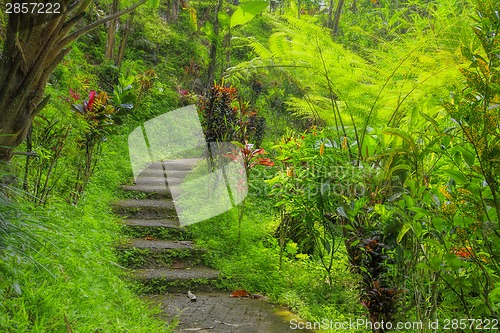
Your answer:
(112, 159), (311, 333)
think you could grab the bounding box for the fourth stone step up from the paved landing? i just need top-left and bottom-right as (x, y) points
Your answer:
(111, 199), (176, 218)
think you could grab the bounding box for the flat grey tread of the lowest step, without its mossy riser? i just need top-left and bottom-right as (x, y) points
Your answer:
(132, 267), (219, 281)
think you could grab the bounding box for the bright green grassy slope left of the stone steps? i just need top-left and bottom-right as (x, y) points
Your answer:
(0, 137), (170, 333)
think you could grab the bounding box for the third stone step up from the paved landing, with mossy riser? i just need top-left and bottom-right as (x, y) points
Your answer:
(122, 218), (190, 240)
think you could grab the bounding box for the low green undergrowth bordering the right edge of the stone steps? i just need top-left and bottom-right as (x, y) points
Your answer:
(189, 189), (363, 332)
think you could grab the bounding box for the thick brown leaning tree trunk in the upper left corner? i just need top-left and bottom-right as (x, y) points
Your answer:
(0, 0), (147, 161)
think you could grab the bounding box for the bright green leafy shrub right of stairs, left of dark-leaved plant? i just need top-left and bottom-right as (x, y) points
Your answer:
(267, 129), (361, 284)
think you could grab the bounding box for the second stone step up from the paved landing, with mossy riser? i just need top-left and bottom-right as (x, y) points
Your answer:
(117, 239), (206, 268)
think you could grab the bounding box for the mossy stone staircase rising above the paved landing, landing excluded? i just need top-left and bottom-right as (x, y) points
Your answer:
(112, 159), (219, 294)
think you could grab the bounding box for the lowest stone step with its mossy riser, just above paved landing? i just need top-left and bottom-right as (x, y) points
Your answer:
(131, 267), (219, 294)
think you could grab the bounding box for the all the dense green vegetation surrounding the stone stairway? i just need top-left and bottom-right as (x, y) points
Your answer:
(0, 0), (500, 333)
